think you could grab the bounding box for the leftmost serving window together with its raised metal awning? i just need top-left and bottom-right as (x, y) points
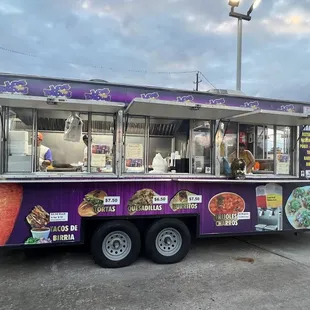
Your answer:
(0, 94), (125, 177)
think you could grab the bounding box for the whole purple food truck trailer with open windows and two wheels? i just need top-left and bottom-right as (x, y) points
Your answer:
(0, 74), (310, 268)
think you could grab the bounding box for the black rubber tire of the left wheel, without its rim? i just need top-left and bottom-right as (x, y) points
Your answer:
(91, 221), (141, 268)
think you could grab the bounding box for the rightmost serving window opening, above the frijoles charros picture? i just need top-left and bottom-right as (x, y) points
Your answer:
(219, 123), (296, 176)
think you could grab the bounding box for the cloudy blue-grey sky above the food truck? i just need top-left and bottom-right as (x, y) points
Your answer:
(0, 0), (310, 101)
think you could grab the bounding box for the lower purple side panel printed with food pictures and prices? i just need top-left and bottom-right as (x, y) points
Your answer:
(0, 182), (310, 245)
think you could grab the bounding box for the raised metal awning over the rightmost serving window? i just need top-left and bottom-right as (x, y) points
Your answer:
(225, 110), (310, 126)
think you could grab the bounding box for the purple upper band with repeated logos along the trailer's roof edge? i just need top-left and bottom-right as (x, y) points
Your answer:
(0, 75), (303, 112)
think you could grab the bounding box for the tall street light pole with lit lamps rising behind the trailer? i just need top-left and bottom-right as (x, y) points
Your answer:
(228, 0), (261, 91)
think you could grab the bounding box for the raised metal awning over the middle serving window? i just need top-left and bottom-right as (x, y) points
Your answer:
(125, 98), (253, 120)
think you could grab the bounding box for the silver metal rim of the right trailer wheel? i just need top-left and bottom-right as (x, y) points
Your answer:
(155, 228), (182, 256)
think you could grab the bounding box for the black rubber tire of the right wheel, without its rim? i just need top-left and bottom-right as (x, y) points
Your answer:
(145, 218), (191, 264)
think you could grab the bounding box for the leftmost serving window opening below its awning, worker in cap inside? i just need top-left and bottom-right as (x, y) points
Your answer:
(3, 107), (115, 176)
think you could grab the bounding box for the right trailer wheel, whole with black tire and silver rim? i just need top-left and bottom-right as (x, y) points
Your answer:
(145, 218), (191, 264)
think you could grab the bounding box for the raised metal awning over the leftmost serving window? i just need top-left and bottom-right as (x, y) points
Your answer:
(0, 94), (125, 114)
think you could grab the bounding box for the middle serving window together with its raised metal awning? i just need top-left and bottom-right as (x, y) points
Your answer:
(123, 98), (253, 174)
